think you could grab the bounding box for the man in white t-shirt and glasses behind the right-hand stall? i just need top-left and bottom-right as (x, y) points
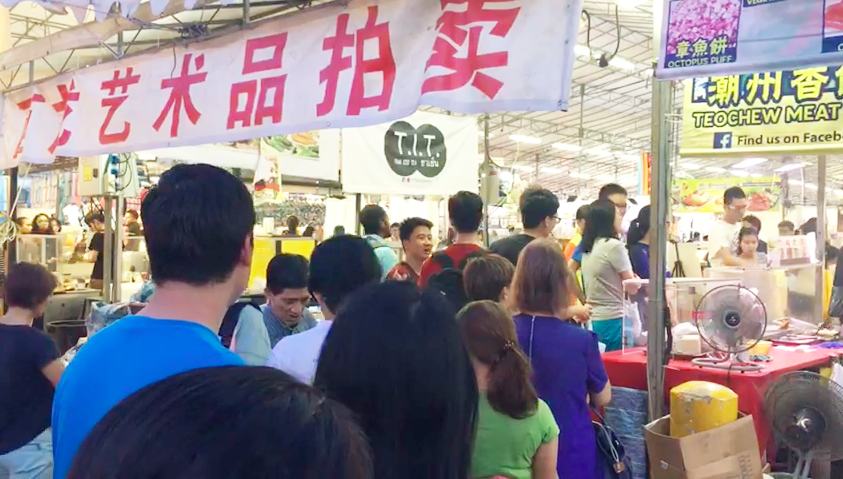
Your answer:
(708, 186), (749, 268)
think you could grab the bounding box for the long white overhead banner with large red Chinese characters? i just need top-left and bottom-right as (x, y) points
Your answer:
(0, 0), (582, 168)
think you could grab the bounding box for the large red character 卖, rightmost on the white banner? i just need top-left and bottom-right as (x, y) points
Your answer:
(422, 0), (521, 99)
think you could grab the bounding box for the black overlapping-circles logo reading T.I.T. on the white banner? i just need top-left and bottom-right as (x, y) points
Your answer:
(383, 121), (448, 178)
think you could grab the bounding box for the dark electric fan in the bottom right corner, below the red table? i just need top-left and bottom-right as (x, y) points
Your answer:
(764, 371), (843, 479)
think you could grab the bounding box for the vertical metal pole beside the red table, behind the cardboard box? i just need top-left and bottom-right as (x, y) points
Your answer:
(647, 80), (671, 421)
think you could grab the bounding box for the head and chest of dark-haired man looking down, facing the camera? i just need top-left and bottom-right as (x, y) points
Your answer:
(261, 253), (316, 349)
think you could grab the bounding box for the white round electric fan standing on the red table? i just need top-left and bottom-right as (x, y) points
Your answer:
(692, 284), (767, 371)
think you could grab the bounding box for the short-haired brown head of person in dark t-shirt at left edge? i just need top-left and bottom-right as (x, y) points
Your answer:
(3, 263), (58, 313)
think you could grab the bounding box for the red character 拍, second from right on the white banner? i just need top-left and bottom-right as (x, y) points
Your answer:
(316, 6), (395, 116)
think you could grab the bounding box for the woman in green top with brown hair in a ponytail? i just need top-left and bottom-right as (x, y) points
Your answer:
(458, 301), (559, 479)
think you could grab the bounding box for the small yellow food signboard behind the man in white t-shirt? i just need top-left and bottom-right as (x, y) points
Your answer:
(673, 177), (781, 213)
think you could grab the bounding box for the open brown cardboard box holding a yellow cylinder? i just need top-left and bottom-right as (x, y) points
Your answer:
(644, 416), (763, 479)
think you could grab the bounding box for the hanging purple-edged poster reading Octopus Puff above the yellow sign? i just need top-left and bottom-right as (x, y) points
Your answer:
(656, 0), (843, 80)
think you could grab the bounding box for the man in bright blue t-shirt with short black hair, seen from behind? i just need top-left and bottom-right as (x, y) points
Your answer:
(52, 165), (255, 479)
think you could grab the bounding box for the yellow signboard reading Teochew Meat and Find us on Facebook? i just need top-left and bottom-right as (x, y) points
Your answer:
(681, 66), (843, 156)
